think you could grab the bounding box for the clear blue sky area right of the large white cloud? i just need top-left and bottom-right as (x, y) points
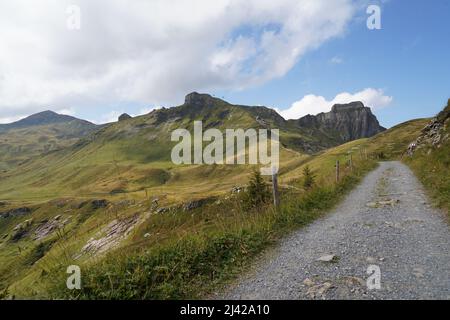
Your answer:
(215, 0), (450, 127)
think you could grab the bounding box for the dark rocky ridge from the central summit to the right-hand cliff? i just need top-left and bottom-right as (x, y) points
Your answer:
(181, 92), (386, 153)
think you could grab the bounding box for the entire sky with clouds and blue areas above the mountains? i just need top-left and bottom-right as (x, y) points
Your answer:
(0, 0), (450, 127)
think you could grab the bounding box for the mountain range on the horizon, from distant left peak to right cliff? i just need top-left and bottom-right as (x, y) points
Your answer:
(0, 92), (385, 174)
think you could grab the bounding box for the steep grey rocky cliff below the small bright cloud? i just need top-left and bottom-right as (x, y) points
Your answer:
(297, 102), (386, 143)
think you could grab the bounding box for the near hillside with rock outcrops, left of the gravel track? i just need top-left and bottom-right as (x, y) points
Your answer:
(0, 140), (375, 299)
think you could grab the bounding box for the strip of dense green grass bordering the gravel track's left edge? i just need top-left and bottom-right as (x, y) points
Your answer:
(50, 152), (375, 299)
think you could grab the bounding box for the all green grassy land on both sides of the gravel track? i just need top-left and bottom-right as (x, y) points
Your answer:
(0, 94), (450, 299)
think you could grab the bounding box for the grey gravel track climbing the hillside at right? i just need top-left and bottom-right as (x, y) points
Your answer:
(220, 161), (450, 300)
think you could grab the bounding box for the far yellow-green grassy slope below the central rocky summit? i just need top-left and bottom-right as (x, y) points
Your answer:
(0, 100), (324, 202)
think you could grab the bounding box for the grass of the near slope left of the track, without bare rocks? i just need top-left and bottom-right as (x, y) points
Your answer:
(0, 140), (375, 298)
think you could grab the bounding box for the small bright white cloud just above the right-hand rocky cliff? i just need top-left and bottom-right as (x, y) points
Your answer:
(277, 88), (393, 119)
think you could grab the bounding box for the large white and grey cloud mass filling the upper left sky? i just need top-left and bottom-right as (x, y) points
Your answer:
(0, 0), (355, 118)
